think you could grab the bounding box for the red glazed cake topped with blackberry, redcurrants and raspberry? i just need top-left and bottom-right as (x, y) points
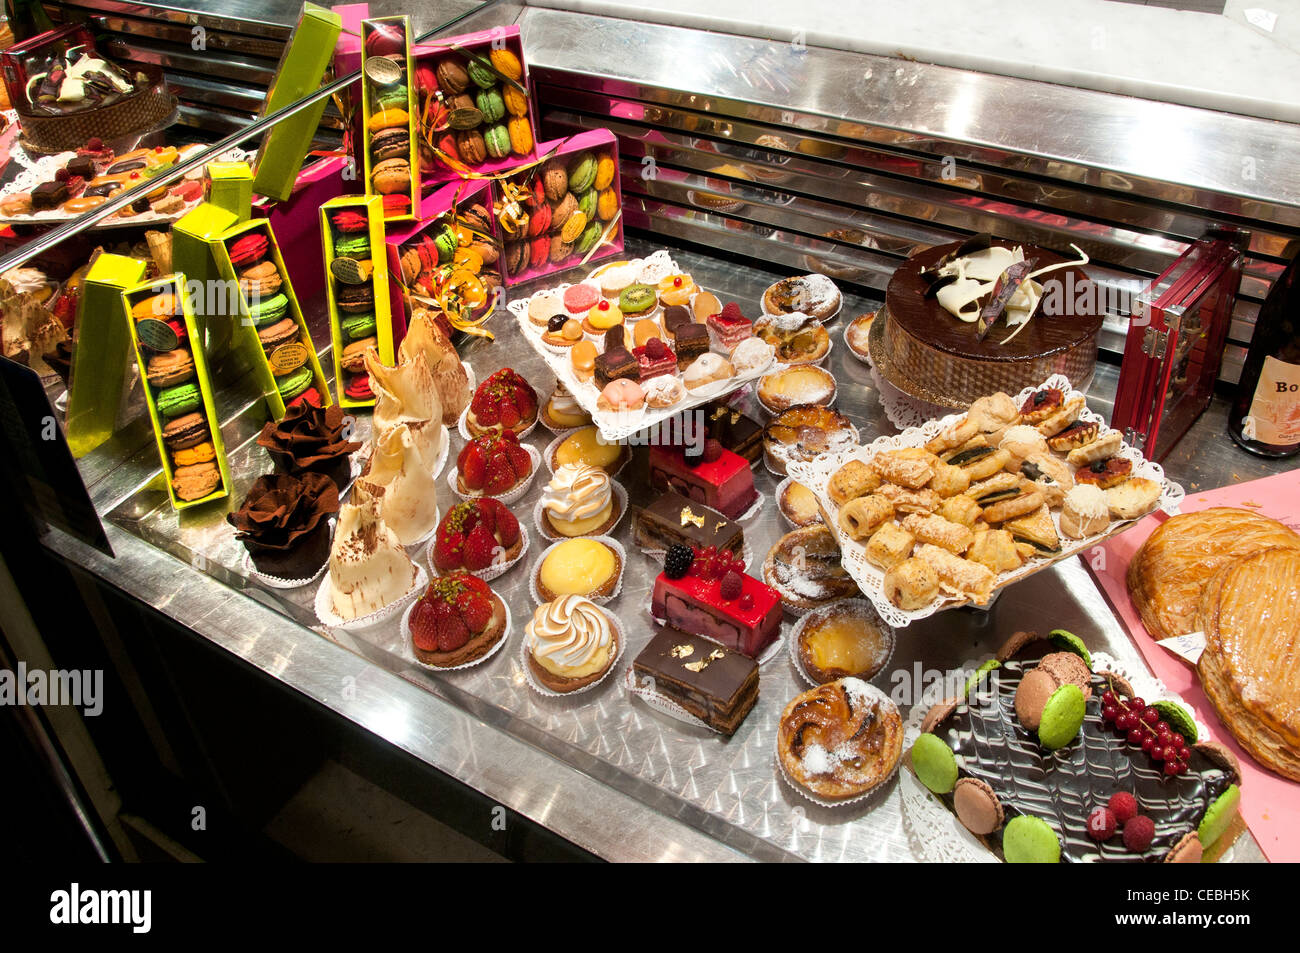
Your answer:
(650, 545), (781, 658)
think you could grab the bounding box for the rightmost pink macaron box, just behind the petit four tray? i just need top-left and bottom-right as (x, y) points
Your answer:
(493, 129), (624, 287)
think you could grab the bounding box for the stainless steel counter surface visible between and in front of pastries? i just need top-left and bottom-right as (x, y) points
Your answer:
(48, 239), (1284, 861)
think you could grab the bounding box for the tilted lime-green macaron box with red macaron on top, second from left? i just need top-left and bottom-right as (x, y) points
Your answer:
(215, 218), (332, 420)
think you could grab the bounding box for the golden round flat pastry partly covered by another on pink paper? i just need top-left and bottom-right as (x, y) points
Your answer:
(1127, 506), (1300, 638)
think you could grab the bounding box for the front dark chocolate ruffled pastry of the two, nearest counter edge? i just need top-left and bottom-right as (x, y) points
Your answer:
(226, 471), (339, 580)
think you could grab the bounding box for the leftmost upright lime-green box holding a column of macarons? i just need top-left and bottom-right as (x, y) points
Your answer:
(122, 274), (230, 510)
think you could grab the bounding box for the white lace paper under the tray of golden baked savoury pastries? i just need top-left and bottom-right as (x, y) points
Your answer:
(787, 374), (1183, 628)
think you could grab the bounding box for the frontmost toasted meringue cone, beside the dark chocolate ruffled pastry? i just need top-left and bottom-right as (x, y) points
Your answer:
(329, 499), (416, 620)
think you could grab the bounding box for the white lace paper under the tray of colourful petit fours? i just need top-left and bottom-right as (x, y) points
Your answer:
(506, 250), (775, 442)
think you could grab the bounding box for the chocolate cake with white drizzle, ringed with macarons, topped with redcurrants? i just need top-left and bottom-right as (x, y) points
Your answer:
(911, 631), (1240, 862)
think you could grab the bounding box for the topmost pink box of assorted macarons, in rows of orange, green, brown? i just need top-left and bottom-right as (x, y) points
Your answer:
(413, 26), (538, 186)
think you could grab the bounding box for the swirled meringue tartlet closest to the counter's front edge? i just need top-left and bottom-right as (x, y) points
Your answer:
(524, 595), (619, 693)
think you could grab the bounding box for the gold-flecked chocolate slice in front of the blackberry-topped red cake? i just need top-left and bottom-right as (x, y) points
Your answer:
(632, 625), (758, 737)
